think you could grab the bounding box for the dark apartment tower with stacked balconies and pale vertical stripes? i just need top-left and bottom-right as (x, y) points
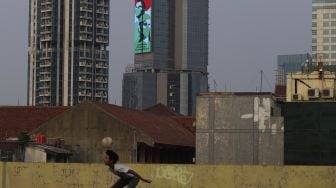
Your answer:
(28, 0), (110, 106)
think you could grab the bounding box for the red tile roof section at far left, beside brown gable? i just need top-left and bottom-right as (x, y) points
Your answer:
(0, 106), (70, 140)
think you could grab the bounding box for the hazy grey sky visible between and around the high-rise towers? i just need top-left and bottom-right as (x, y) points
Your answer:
(0, 0), (311, 105)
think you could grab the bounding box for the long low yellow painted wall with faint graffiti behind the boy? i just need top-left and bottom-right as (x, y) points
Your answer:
(0, 163), (336, 188)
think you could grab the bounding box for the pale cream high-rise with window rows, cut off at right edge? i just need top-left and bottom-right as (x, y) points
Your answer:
(312, 0), (336, 65)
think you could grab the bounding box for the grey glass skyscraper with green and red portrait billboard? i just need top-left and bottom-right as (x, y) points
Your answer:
(122, 0), (209, 115)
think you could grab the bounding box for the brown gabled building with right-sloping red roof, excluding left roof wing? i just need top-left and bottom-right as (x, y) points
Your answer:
(32, 102), (195, 163)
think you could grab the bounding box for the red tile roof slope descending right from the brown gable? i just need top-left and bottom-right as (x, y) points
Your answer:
(95, 103), (195, 147)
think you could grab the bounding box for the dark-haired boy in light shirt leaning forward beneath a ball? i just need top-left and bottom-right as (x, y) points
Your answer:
(104, 150), (152, 188)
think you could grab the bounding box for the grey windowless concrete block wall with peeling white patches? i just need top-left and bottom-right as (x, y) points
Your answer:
(196, 94), (283, 165)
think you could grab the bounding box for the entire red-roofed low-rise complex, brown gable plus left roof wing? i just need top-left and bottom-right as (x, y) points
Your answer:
(0, 102), (195, 163)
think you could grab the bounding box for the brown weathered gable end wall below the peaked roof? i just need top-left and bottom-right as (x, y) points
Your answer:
(34, 103), (151, 163)
